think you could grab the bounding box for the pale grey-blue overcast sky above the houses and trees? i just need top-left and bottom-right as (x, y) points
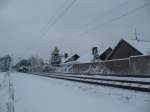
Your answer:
(0, 0), (150, 58)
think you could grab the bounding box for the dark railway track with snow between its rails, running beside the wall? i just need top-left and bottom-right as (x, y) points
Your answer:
(30, 73), (150, 92)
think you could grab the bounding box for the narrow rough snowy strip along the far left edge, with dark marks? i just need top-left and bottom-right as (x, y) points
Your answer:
(0, 72), (14, 112)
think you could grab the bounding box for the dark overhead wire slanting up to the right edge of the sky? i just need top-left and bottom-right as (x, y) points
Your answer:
(81, 2), (150, 35)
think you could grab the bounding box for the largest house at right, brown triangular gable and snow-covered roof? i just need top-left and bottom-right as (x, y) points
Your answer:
(107, 39), (150, 60)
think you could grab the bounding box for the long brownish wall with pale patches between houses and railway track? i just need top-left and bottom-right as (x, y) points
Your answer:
(72, 55), (150, 75)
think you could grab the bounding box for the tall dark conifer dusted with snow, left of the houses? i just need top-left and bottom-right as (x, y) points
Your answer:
(50, 47), (61, 67)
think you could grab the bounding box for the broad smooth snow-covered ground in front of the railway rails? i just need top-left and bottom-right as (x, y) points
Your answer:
(12, 73), (150, 112)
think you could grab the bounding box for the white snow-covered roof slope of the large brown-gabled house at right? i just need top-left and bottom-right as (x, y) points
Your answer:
(126, 40), (150, 55)
